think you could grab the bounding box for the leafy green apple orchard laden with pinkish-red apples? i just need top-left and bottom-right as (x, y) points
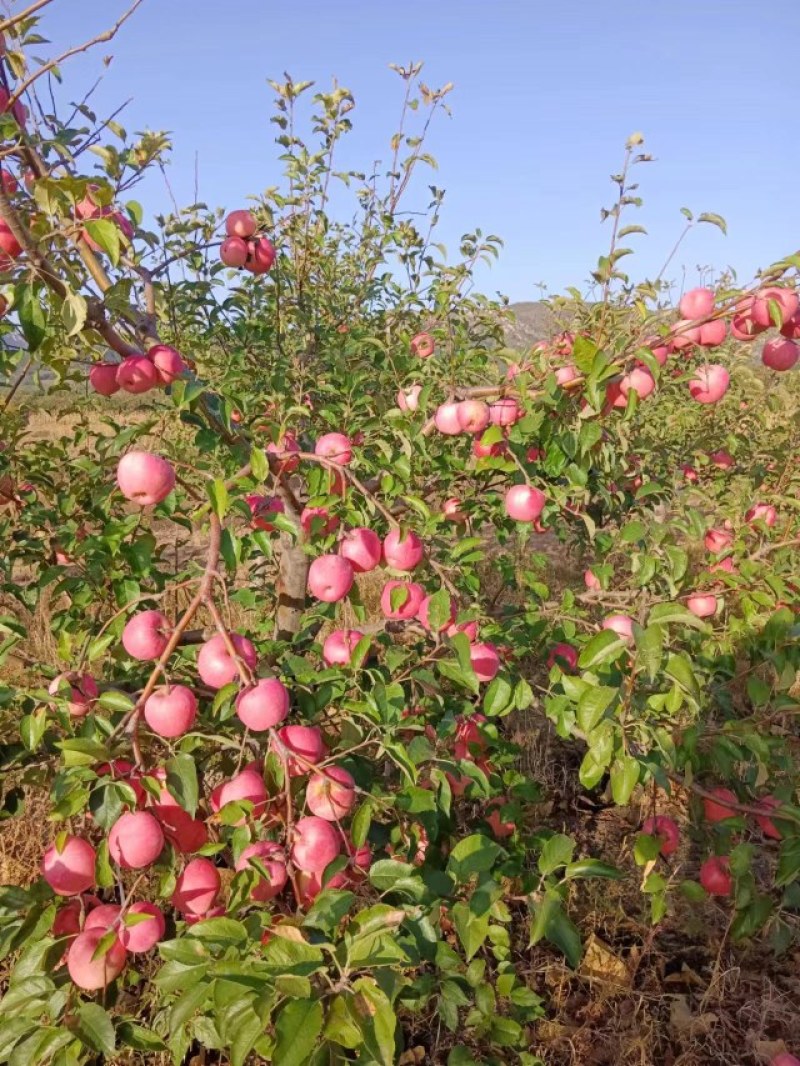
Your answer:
(0, 4), (800, 1066)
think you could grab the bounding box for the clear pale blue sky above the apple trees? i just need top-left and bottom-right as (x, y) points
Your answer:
(31, 0), (800, 300)
